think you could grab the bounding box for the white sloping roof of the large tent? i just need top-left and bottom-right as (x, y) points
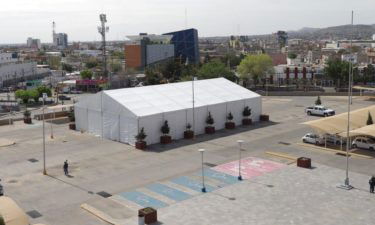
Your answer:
(104, 78), (259, 116)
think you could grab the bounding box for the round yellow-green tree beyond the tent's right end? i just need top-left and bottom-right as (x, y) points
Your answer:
(237, 54), (274, 84)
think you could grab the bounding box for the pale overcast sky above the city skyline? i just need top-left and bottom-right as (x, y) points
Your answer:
(0, 0), (375, 44)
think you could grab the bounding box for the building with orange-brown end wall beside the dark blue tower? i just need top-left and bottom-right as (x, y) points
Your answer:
(125, 33), (175, 69)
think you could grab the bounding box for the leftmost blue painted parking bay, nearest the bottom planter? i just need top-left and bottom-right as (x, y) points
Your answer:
(119, 191), (168, 209)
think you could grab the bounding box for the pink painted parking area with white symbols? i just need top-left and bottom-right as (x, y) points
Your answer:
(212, 157), (286, 179)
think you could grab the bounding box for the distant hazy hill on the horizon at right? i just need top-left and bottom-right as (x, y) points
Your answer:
(288, 24), (375, 40)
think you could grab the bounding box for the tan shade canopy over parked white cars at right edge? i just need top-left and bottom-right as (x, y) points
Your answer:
(303, 106), (375, 134)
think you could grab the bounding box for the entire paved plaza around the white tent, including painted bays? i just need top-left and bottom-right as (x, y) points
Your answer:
(0, 97), (375, 225)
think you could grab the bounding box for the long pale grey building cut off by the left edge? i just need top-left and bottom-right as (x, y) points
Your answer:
(0, 53), (37, 87)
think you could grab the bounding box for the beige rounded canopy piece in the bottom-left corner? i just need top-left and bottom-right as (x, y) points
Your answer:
(0, 196), (29, 225)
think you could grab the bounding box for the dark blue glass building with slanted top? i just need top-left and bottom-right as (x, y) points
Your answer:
(165, 29), (200, 64)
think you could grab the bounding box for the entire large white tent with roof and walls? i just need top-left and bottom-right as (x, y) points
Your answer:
(74, 78), (262, 145)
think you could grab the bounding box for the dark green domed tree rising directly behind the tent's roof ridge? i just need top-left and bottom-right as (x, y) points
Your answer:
(198, 59), (237, 81)
